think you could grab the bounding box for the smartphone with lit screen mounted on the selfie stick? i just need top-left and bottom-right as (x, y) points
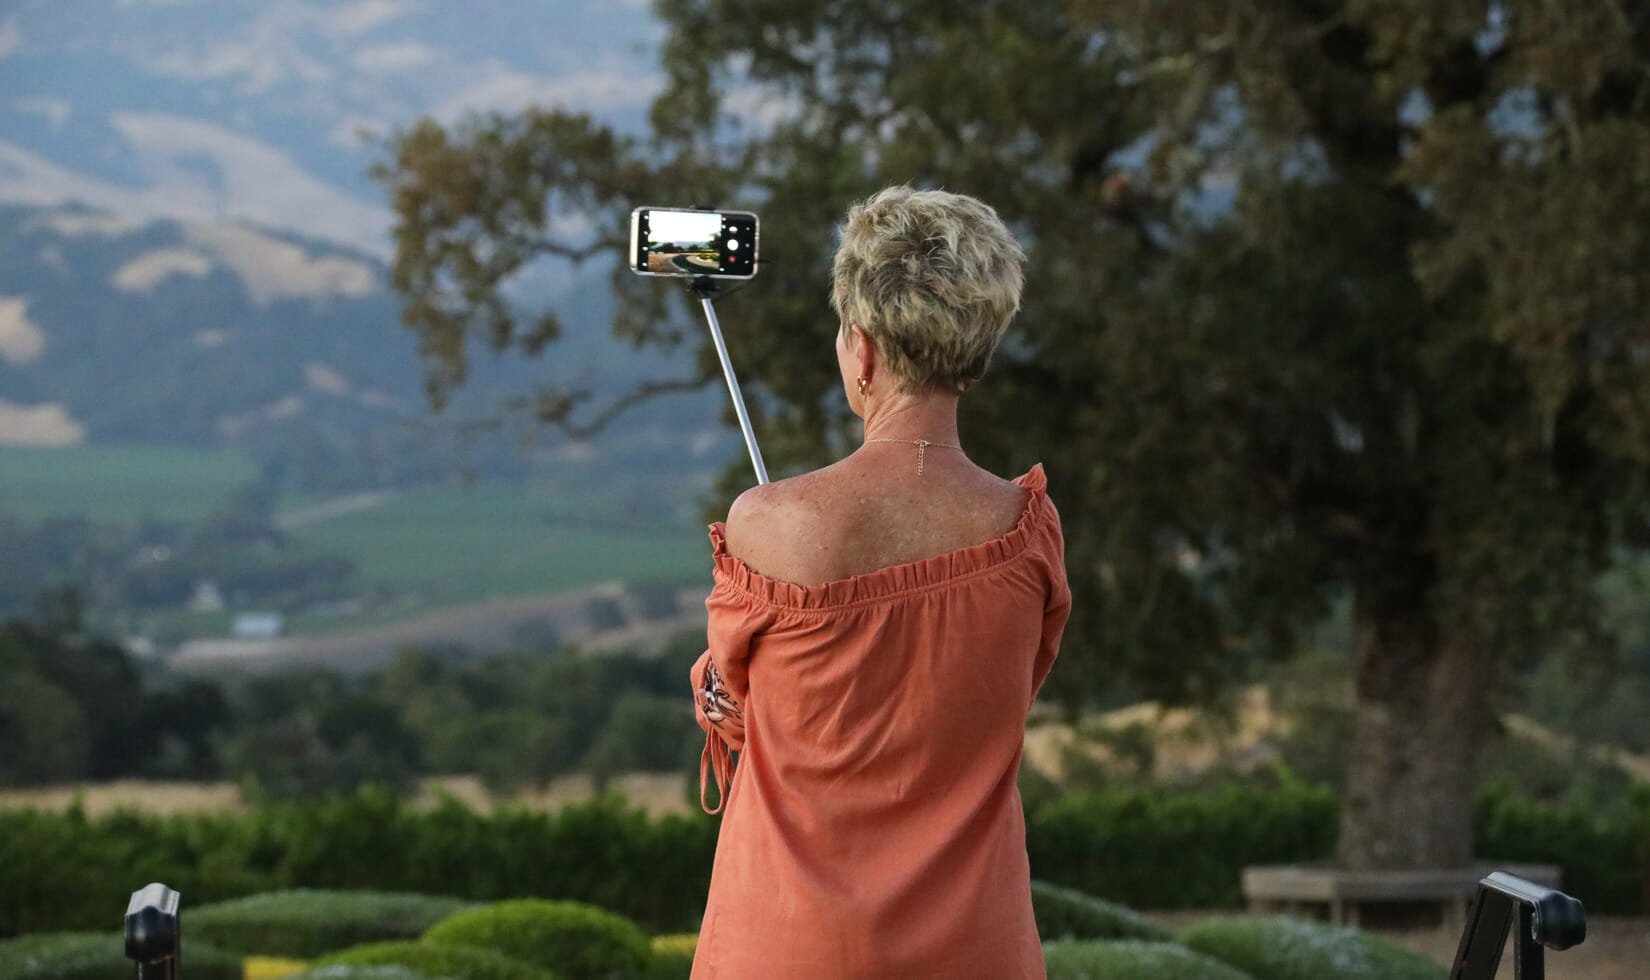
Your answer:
(630, 208), (757, 279)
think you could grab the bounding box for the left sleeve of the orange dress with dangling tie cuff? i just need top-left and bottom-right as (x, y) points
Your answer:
(690, 582), (762, 813)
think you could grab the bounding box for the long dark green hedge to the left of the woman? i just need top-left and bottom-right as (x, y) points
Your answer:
(0, 792), (716, 935)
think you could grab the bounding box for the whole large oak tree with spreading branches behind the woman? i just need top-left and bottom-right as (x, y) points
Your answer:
(381, 0), (1650, 868)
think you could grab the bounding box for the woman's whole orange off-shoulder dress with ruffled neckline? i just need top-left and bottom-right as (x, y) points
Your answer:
(693, 465), (1071, 980)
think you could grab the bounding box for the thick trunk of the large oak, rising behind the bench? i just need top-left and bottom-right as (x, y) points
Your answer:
(1337, 594), (1490, 869)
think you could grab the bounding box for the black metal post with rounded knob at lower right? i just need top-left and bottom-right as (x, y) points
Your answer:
(1450, 871), (1587, 980)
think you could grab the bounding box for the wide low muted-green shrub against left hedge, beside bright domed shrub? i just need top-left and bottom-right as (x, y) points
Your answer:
(193, 889), (472, 972)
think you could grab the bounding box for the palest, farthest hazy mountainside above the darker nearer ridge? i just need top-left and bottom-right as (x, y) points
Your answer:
(0, 0), (658, 257)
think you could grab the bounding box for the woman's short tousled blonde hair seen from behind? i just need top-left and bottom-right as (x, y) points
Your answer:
(830, 186), (1025, 391)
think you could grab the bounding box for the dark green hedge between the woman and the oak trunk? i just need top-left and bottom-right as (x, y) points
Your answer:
(1026, 782), (1338, 909)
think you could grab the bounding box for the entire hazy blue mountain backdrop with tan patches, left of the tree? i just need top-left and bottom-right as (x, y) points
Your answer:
(0, 0), (719, 482)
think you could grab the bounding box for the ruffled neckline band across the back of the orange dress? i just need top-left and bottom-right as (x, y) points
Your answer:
(710, 464), (1048, 609)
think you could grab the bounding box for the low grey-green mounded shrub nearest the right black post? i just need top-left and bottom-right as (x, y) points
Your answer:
(1180, 916), (1449, 980)
